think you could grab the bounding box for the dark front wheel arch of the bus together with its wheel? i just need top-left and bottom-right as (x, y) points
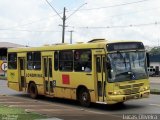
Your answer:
(76, 85), (91, 107)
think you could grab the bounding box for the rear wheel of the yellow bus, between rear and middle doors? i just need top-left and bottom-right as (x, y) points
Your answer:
(29, 83), (38, 99)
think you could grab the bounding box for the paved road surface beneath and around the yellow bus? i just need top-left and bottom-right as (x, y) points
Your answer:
(0, 80), (160, 120)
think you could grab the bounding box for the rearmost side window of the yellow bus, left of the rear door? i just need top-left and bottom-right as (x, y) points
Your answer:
(8, 53), (17, 69)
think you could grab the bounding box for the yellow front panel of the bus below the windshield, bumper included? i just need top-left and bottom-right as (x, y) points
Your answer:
(106, 79), (150, 104)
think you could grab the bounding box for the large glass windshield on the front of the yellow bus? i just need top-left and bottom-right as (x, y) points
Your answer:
(107, 51), (148, 82)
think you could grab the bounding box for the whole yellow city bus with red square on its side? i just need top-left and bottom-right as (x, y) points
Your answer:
(7, 39), (150, 106)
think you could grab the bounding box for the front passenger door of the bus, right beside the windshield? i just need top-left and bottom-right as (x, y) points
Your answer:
(96, 55), (106, 102)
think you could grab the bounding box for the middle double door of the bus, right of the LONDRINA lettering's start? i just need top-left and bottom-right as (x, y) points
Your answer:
(43, 57), (54, 95)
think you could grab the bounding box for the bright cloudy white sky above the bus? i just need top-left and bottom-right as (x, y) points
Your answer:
(0, 0), (160, 46)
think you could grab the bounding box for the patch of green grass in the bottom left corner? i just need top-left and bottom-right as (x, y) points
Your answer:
(0, 105), (47, 120)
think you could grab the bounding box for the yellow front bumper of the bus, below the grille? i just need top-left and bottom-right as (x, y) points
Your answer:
(107, 90), (150, 104)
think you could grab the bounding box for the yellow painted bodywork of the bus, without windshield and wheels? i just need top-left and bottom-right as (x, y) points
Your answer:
(7, 41), (150, 104)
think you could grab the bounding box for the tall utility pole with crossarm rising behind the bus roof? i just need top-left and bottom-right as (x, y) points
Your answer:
(62, 7), (66, 43)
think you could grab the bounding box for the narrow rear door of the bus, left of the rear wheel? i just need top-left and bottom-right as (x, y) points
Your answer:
(18, 57), (27, 91)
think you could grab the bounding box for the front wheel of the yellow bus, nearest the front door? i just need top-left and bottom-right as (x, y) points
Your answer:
(78, 88), (91, 107)
